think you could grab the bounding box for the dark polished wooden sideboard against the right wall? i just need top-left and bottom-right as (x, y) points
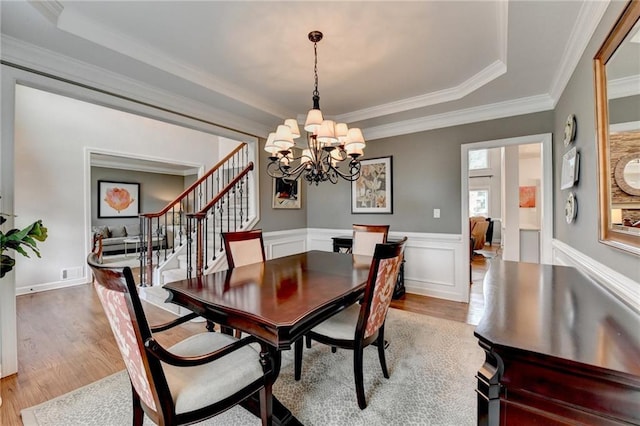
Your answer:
(475, 261), (640, 425)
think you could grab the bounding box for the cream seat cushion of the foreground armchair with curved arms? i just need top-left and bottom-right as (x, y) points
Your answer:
(162, 333), (263, 413)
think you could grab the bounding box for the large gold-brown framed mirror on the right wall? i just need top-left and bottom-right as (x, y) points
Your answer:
(594, 0), (640, 255)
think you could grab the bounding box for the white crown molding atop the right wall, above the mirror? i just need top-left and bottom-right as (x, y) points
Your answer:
(549, 0), (609, 107)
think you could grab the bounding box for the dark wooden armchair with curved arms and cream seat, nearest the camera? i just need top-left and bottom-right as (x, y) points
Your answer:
(87, 254), (272, 425)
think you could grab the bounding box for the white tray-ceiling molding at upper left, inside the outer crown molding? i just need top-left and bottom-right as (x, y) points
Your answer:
(57, 9), (293, 117)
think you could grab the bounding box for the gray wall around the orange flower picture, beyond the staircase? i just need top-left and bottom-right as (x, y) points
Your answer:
(91, 167), (194, 225)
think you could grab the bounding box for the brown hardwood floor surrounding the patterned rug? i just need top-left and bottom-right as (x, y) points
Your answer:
(0, 246), (496, 426)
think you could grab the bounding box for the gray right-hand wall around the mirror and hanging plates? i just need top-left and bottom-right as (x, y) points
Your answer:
(553, 2), (640, 281)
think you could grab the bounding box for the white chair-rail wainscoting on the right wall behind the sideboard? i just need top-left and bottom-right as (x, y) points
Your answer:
(552, 239), (640, 313)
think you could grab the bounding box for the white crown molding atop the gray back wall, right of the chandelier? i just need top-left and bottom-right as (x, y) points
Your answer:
(362, 94), (554, 140)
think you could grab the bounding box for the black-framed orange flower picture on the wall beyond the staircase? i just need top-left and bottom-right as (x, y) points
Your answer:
(98, 180), (140, 218)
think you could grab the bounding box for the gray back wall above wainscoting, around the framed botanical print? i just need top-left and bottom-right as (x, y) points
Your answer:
(296, 112), (552, 234)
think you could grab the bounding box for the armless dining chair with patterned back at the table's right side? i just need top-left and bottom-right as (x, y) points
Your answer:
(294, 237), (407, 409)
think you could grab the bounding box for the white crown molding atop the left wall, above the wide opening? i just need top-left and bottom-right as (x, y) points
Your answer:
(0, 34), (269, 135)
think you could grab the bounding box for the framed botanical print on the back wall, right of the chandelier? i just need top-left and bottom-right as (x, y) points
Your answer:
(351, 156), (393, 213)
